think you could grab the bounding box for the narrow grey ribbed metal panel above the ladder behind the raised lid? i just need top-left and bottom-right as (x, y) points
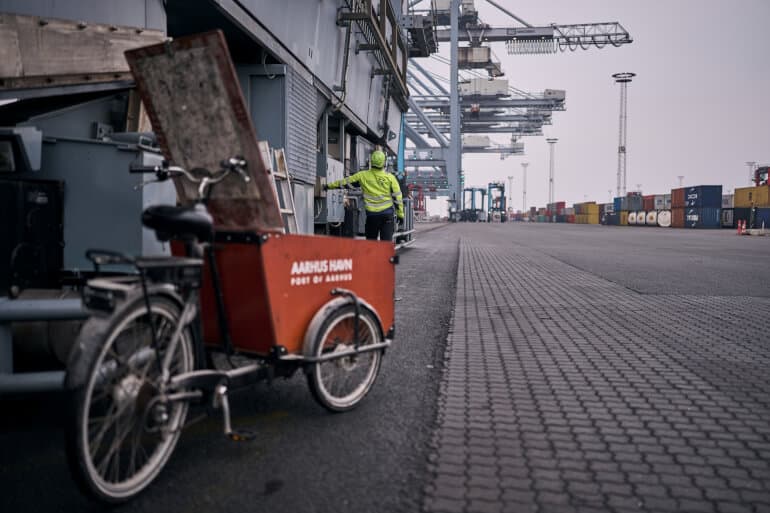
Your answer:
(286, 67), (317, 185)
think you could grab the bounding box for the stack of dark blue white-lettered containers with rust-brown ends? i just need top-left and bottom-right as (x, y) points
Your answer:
(671, 185), (722, 228)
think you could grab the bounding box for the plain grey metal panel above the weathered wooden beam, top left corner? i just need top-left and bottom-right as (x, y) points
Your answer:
(0, 0), (166, 33)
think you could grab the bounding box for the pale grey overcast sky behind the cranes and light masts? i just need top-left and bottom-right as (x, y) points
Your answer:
(421, 0), (770, 213)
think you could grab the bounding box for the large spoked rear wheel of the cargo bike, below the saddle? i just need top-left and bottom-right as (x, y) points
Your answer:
(65, 296), (194, 502)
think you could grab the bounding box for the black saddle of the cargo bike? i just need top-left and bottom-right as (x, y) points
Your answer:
(142, 204), (214, 242)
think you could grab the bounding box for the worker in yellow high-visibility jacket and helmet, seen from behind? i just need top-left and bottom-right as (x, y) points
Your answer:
(326, 150), (404, 240)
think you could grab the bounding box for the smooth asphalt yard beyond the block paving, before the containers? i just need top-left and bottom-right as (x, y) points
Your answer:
(504, 223), (770, 297)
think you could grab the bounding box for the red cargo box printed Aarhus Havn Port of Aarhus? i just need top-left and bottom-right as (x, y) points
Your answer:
(196, 234), (395, 355)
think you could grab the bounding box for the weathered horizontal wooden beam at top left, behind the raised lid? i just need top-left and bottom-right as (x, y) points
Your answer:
(0, 13), (166, 88)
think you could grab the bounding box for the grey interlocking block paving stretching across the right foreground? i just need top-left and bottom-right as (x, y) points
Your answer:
(424, 229), (770, 513)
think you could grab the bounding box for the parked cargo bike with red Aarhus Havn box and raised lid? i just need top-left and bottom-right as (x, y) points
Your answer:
(65, 33), (397, 502)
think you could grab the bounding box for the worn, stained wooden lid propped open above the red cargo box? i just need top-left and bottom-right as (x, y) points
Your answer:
(126, 31), (283, 232)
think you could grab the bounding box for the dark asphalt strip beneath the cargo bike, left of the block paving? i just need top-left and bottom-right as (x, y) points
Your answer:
(0, 228), (457, 513)
